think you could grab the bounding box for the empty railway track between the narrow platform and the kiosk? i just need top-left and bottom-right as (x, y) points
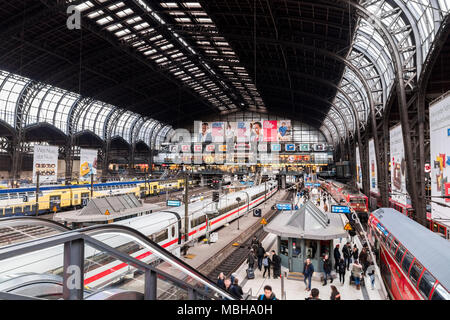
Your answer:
(198, 192), (291, 281)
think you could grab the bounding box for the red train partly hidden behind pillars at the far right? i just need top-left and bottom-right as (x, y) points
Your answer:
(370, 191), (450, 240)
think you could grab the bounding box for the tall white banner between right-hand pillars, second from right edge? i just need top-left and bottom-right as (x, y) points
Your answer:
(389, 125), (410, 205)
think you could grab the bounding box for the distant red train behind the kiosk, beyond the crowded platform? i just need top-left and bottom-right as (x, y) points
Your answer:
(320, 180), (369, 223)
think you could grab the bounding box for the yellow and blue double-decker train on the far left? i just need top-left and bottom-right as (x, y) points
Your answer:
(0, 179), (194, 217)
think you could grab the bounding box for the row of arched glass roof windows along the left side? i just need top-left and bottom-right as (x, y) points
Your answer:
(0, 71), (171, 146)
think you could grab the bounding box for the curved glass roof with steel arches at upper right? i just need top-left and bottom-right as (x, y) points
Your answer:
(322, 0), (450, 143)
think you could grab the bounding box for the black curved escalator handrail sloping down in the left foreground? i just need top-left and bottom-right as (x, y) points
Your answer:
(76, 225), (231, 296)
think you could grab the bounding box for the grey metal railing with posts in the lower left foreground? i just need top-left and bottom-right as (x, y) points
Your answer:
(0, 218), (234, 300)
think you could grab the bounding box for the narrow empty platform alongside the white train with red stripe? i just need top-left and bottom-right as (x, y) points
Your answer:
(181, 190), (287, 268)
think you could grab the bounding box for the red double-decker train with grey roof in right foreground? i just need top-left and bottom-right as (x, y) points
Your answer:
(368, 208), (450, 300)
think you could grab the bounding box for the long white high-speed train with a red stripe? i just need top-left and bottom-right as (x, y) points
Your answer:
(0, 181), (277, 289)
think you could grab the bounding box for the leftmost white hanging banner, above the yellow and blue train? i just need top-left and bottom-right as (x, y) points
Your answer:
(33, 145), (58, 183)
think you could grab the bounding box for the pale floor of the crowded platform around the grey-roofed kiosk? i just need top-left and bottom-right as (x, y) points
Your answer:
(235, 192), (384, 300)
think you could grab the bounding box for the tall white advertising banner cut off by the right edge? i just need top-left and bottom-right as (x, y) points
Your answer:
(430, 94), (450, 220)
